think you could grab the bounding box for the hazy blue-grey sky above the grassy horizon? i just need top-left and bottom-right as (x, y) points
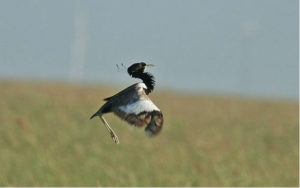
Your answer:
(0, 0), (299, 100)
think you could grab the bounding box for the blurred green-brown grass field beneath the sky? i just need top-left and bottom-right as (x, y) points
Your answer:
(0, 82), (299, 186)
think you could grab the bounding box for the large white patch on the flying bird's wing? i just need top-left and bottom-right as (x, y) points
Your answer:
(119, 100), (160, 114)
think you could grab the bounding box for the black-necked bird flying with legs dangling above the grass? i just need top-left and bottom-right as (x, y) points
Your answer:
(90, 62), (164, 144)
